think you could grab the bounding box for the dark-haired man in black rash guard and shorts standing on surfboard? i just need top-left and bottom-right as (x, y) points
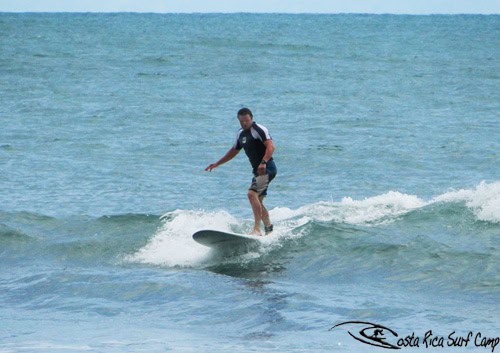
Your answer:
(205, 108), (277, 235)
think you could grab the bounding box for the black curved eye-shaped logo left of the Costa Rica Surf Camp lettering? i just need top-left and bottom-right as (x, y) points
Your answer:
(329, 321), (401, 349)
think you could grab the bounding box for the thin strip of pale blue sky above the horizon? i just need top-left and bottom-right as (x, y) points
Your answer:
(0, 0), (500, 15)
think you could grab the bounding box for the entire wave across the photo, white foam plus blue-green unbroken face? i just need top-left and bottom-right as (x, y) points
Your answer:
(0, 182), (500, 276)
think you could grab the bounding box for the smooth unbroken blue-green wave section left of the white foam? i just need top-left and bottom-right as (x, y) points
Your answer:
(0, 212), (160, 263)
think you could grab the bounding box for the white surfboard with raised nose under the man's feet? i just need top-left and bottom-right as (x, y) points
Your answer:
(193, 230), (261, 249)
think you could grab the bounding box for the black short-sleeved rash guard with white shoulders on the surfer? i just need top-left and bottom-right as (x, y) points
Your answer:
(234, 121), (272, 173)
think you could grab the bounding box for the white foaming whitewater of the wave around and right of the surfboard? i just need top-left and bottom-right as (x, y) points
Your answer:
(125, 182), (500, 267)
